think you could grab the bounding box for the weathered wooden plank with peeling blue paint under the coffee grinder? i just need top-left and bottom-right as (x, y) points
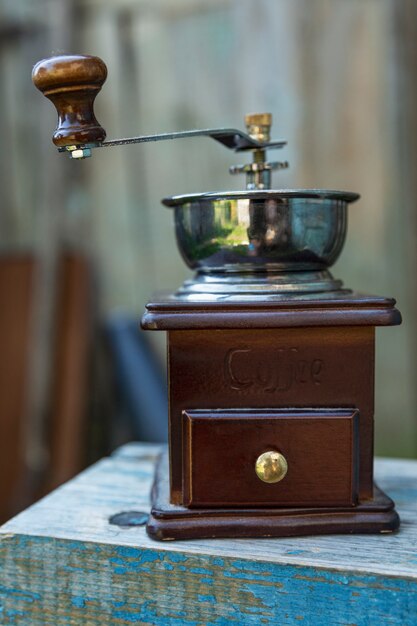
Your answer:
(0, 444), (417, 626)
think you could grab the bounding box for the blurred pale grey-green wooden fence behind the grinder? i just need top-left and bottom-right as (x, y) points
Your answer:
(0, 0), (417, 488)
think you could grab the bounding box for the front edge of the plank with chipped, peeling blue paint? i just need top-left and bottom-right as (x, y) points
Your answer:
(0, 537), (417, 626)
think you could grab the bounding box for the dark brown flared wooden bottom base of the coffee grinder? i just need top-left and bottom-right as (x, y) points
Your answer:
(146, 452), (400, 541)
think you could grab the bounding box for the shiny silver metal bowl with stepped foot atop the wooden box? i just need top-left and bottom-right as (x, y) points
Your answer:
(163, 189), (359, 295)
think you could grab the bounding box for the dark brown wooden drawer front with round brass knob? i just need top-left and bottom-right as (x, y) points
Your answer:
(182, 408), (359, 507)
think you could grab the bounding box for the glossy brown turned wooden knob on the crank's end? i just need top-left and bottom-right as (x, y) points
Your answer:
(32, 55), (107, 146)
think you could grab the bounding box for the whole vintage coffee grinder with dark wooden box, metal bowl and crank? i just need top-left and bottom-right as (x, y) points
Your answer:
(33, 56), (401, 539)
